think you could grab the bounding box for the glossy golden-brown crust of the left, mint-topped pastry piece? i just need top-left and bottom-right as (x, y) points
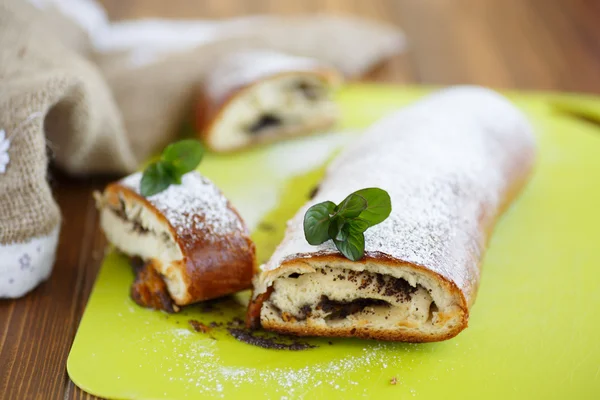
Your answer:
(102, 171), (256, 306)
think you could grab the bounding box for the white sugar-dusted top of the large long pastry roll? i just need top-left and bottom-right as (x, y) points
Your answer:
(262, 87), (535, 300)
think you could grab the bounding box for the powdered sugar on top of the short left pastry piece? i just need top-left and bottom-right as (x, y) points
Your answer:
(121, 171), (247, 242)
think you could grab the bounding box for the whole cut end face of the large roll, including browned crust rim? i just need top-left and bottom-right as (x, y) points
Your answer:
(249, 254), (468, 342)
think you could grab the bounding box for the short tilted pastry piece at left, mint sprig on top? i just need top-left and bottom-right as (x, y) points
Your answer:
(97, 172), (255, 312)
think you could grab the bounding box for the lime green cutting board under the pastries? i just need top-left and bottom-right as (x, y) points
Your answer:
(67, 84), (600, 399)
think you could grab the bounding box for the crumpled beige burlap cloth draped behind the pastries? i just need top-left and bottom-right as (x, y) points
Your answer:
(0, 0), (398, 297)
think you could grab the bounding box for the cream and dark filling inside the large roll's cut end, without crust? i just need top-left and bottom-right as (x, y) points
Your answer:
(262, 266), (437, 326)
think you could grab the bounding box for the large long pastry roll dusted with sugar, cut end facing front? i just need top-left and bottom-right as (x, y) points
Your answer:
(248, 87), (535, 342)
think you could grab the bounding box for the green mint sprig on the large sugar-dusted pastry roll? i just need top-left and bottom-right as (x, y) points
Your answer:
(304, 188), (392, 261)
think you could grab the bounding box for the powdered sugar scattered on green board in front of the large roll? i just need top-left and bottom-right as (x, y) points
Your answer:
(140, 332), (414, 398)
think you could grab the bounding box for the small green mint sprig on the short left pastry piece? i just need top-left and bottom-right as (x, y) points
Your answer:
(140, 139), (204, 197)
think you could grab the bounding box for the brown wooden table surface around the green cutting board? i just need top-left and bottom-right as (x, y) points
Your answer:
(0, 0), (600, 399)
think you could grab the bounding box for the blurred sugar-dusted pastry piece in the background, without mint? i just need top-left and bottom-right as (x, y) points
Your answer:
(197, 50), (341, 152)
